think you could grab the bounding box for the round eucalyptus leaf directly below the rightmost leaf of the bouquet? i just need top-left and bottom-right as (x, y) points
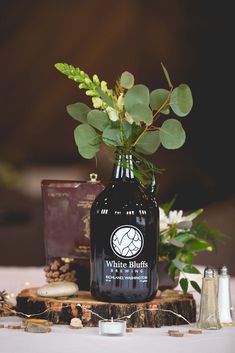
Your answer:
(160, 119), (186, 150)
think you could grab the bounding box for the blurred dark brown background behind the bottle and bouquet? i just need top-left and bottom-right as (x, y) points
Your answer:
(0, 0), (235, 274)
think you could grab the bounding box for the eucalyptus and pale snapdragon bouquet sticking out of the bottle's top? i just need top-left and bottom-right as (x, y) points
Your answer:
(55, 63), (193, 186)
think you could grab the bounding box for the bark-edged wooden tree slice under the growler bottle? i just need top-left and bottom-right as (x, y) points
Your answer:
(16, 288), (196, 327)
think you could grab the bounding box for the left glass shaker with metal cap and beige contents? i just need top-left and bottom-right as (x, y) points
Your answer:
(197, 267), (221, 330)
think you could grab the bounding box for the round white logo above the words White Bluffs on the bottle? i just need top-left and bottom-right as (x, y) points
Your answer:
(110, 225), (144, 259)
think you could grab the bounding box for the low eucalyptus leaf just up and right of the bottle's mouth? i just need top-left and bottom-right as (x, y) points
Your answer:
(136, 131), (160, 154)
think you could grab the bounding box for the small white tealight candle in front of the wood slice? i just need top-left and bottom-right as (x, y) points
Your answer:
(99, 318), (126, 336)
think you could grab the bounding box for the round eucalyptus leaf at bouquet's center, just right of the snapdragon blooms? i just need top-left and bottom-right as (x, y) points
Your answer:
(125, 85), (150, 113)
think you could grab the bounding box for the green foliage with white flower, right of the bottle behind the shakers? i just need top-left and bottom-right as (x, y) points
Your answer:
(159, 198), (224, 293)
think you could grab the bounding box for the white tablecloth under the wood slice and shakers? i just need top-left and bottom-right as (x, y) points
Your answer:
(0, 267), (235, 353)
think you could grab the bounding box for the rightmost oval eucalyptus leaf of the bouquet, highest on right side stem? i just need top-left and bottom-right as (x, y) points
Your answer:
(170, 83), (193, 117)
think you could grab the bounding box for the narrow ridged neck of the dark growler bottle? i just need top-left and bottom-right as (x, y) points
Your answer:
(112, 150), (135, 180)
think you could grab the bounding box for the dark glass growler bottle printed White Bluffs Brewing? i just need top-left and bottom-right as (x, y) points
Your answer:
(90, 151), (159, 303)
